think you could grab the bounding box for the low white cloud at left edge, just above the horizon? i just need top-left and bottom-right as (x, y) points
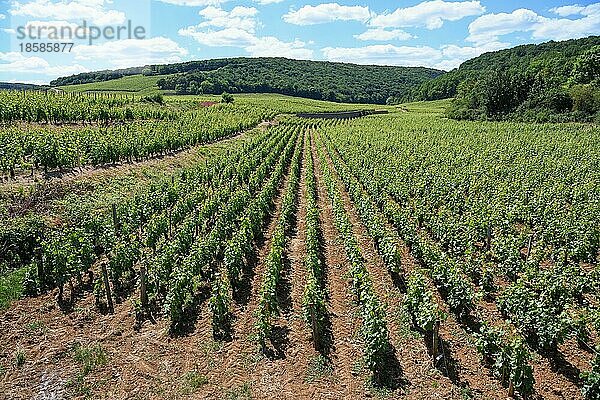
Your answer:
(0, 52), (88, 77)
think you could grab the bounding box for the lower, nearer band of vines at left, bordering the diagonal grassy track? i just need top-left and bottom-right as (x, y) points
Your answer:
(0, 105), (274, 177)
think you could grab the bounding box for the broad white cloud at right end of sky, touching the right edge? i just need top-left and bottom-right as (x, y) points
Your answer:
(467, 3), (600, 45)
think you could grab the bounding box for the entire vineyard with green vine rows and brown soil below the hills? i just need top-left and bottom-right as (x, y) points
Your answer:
(0, 92), (600, 399)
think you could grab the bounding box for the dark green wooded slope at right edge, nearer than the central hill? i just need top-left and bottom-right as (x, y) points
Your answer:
(404, 36), (600, 122)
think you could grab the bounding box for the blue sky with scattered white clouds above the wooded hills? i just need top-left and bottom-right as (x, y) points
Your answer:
(0, 0), (600, 84)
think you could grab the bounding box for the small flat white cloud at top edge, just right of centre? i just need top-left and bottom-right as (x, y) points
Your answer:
(283, 3), (371, 25)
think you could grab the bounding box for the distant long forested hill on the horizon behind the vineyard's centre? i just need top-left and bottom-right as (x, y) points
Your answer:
(51, 58), (444, 104)
